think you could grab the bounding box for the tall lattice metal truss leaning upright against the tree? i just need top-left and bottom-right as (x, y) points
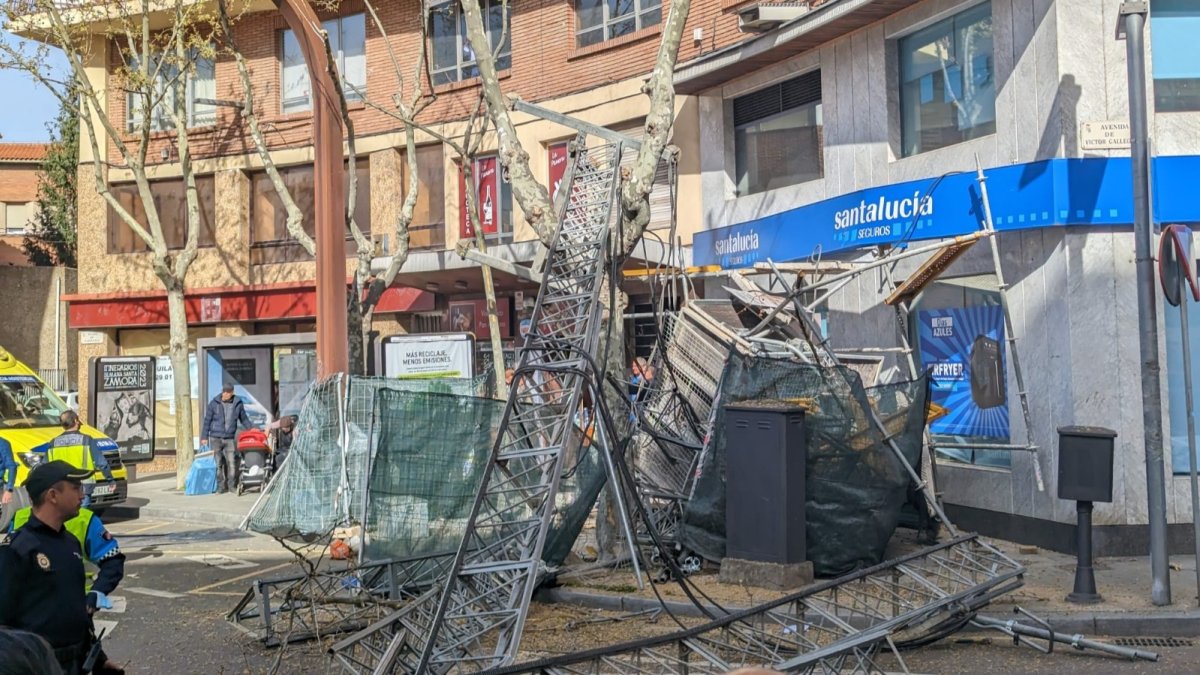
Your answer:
(332, 133), (622, 673)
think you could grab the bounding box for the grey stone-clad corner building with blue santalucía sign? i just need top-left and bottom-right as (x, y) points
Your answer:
(676, 0), (1200, 554)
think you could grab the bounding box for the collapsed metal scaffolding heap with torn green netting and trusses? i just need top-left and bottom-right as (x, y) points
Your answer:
(229, 112), (1137, 673)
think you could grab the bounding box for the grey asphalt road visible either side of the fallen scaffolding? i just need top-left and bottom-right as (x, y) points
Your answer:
(97, 511), (1200, 675)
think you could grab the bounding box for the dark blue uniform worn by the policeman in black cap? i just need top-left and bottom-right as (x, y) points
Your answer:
(0, 515), (91, 675)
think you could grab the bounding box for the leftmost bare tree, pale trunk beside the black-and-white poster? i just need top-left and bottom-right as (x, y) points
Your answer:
(0, 0), (226, 488)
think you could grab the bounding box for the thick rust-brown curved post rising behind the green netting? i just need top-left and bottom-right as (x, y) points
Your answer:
(275, 0), (348, 377)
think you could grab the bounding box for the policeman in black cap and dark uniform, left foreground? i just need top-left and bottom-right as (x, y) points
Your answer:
(0, 460), (116, 675)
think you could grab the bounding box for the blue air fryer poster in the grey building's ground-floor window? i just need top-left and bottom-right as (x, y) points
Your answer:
(917, 305), (1008, 441)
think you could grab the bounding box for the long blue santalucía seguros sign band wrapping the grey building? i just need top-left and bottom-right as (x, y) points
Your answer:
(692, 155), (1200, 269)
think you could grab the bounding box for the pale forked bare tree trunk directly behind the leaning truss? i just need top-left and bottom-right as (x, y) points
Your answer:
(461, 0), (691, 555)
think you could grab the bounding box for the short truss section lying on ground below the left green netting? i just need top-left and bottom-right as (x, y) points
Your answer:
(226, 552), (454, 647)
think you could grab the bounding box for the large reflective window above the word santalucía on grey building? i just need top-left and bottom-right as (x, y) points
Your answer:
(900, 2), (996, 157)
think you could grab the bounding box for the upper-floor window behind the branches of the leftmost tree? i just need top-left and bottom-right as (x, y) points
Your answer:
(125, 49), (217, 131)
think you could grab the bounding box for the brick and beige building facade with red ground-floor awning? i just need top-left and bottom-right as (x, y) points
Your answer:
(56, 0), (787, 456)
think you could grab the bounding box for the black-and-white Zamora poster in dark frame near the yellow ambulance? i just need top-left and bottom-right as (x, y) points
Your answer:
(88, 357), (157, 462)
